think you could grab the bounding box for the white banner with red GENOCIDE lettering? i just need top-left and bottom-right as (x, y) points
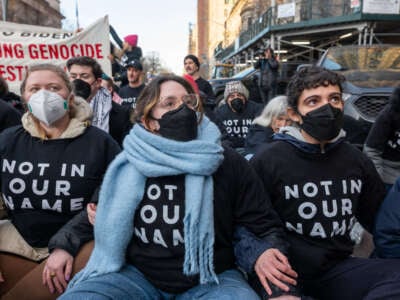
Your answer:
(0, 16), (111, 94)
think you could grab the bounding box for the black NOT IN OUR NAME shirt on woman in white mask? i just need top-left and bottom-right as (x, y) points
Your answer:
(0, 126), (120, 247)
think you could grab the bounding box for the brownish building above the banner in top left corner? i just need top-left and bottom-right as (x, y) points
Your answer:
(0, 0), (64, 28)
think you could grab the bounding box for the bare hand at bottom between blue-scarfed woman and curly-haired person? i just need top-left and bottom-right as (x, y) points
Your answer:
(254, 249), (297, 295)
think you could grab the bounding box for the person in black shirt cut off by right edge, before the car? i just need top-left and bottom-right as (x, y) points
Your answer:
(364, 87), (400, 189)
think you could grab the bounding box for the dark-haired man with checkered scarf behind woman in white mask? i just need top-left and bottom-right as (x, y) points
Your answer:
(67, 56), (132, 145)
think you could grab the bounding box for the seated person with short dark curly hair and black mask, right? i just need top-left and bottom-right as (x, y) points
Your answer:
(251, 66), (400, 300)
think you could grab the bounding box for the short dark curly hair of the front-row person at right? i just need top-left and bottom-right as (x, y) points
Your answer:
(286, 66), (346, 108)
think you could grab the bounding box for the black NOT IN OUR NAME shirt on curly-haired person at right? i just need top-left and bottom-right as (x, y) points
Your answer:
(251, 141), (386, 279)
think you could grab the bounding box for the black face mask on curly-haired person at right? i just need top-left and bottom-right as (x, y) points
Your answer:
(300, 104), (343, 141)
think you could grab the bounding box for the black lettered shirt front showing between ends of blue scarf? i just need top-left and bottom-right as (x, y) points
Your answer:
(128, 175), (197, 291)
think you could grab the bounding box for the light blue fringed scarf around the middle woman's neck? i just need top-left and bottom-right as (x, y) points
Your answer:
(69, 118), (223, 286)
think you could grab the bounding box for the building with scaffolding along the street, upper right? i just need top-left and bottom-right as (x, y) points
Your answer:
(197, 0), (400, 78)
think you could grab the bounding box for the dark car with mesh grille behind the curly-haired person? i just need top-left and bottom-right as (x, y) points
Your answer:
(317, 44), (400, 126)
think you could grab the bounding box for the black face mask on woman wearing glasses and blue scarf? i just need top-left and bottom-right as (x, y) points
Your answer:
(157, 104), (197, 142)
